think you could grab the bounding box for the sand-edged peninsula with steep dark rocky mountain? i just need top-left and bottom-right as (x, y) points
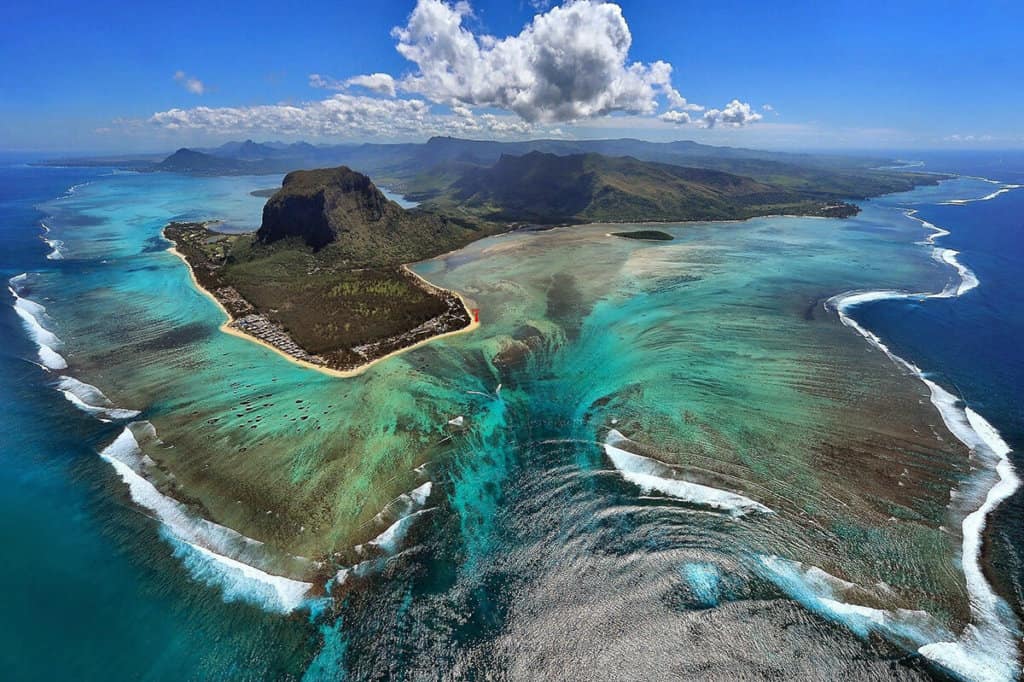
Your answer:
(164, 167), (485, 376)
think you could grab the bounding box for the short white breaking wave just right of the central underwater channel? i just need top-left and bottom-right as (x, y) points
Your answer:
(604, 429), (772, 516)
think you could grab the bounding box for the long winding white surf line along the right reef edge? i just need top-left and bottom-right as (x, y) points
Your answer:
(826, 206), (1020, 680)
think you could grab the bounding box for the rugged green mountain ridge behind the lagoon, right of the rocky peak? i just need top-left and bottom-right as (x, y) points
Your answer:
(437, 152), (851, 223)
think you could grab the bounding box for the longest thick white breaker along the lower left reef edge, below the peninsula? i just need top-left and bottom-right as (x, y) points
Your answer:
(99, 422), (312, 613)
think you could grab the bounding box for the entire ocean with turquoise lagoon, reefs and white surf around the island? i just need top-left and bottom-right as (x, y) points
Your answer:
(0, 153), (1024, 679)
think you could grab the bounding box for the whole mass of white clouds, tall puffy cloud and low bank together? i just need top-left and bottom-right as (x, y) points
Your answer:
(148, 0), (771, 138)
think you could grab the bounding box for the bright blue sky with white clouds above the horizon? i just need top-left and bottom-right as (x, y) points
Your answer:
(0, 0), (1024, 153)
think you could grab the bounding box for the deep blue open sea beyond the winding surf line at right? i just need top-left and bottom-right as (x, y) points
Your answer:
(857, 153), (1024, 610)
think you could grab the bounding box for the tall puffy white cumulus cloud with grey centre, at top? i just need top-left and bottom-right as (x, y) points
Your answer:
(392, 0), (685, 122)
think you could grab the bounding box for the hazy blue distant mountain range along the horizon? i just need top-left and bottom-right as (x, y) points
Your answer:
(125, 137), (937, 202)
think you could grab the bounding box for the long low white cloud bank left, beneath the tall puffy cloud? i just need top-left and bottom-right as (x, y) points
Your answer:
(148, 93), (534, 138)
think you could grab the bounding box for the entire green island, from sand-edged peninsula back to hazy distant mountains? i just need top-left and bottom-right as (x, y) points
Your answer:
(153, 138), (943, 376)
